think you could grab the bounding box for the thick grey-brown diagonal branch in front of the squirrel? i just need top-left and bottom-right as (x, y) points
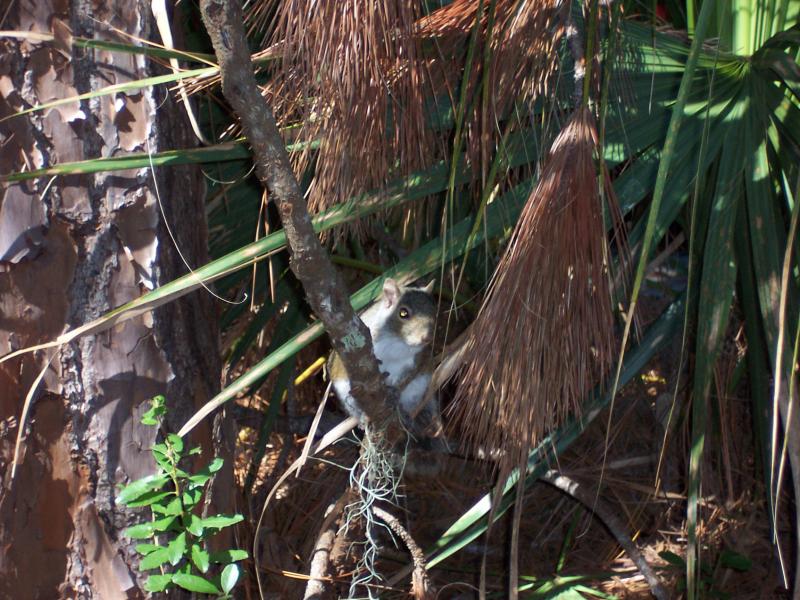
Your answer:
(200, 0), (400, 432)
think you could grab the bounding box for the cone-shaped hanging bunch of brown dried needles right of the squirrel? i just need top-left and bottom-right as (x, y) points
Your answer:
(454, 108), (614, 470)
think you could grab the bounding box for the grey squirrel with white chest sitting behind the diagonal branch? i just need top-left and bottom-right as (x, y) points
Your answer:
(328, 279), (440, 430)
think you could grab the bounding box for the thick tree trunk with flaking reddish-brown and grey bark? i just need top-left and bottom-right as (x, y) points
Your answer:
(0, 0), (223, 600)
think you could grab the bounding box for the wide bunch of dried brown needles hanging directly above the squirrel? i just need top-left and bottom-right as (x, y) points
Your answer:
(253, 0), (434, 225)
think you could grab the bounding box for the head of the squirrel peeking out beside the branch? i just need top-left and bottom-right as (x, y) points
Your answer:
(381, 279), (436, 346)
